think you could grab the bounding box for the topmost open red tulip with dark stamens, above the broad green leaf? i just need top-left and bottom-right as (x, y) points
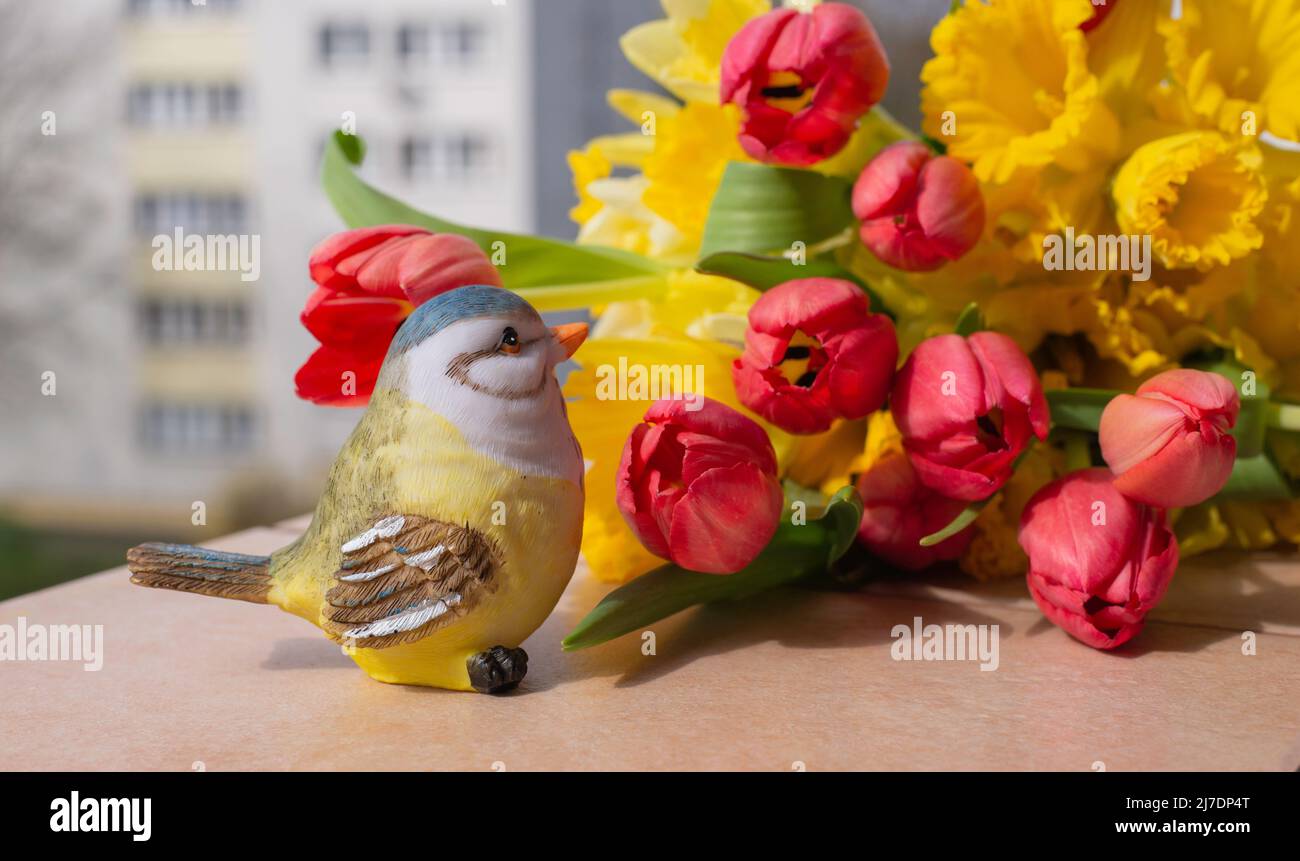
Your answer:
(722, 3), (889, 165)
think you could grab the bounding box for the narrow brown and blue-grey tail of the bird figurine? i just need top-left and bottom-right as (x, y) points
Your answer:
(126, 544), (270, 603)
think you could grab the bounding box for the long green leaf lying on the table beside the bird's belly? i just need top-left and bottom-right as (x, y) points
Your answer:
(563, 486), (862, 652)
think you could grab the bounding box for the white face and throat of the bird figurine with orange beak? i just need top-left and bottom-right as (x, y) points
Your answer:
(390, 310), (586, 480)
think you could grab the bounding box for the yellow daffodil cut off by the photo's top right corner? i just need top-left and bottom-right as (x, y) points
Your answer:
(1164, 0), (1300, 140)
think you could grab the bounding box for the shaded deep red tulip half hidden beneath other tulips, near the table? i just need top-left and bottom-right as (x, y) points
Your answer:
(858, 453), (975, 571)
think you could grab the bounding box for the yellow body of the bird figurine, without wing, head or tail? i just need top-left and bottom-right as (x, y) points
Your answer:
(270, 407), (582, 691)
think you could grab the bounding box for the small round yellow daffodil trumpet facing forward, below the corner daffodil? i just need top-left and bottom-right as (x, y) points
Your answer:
(1113, 131), (1268, 269)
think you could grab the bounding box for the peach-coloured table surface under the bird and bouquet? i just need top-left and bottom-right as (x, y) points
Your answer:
(0, 519), (1300, 771)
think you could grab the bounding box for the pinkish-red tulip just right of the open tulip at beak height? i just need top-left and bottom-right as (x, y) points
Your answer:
(889, 332), (1049, 501)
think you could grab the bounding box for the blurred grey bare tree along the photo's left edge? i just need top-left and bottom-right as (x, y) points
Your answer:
(0, 0), (121, 398)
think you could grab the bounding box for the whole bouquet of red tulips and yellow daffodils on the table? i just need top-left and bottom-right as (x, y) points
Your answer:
(298, 0), (1300, 658)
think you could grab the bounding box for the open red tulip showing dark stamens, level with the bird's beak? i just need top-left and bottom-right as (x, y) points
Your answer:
(732, 278), (898, 433)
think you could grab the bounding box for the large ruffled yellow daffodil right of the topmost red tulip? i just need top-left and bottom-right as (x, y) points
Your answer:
(920, 0), (1119, 182)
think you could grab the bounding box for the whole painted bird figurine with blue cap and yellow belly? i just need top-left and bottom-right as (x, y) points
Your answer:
(127, 286), (586, 693)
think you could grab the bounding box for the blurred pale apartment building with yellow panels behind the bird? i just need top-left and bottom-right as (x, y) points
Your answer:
(0, 0), (535, 537)
